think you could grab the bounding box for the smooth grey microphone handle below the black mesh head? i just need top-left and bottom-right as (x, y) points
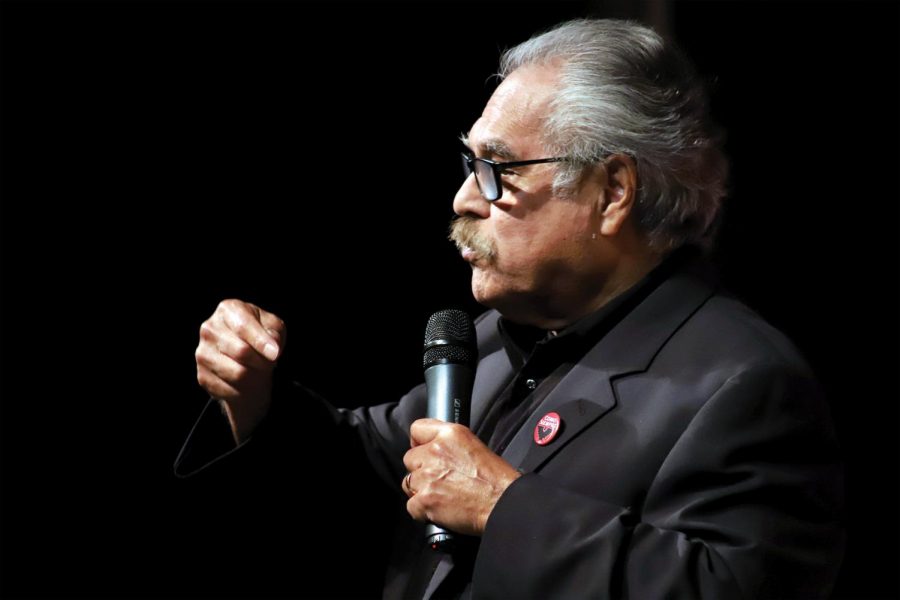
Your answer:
(425, 363), (474, 552)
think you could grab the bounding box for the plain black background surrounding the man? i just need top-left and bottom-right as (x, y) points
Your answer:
(0, 2), (900, 598)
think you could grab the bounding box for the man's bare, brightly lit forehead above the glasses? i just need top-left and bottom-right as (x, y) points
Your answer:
(468, 66), (558, 160)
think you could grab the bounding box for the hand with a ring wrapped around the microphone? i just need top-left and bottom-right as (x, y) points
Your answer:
(402, 419), (521, 535)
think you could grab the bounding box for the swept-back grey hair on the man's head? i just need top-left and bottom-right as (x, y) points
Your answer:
(499, 19), (728, 251)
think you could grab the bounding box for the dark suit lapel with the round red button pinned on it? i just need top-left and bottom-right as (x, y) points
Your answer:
(503, 269), (714, 473)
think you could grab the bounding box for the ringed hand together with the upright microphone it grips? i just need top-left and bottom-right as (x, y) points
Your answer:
(402, 311), (520, 550)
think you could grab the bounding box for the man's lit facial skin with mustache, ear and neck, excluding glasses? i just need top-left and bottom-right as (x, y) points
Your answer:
(451, 66), (658, 329)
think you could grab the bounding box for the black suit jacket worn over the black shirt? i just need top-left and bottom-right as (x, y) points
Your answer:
(176, 264), (844, 599)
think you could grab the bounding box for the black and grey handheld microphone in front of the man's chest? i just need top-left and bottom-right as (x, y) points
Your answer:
(422, 310), (478, 551)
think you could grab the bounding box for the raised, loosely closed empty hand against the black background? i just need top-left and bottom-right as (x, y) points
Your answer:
(194, 300), (287, 443)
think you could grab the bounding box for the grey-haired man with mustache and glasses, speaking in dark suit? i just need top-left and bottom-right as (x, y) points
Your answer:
(177, 20), (843, 598)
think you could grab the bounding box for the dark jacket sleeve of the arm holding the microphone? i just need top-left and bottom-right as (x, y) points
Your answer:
(472, 365), (844, 599)
